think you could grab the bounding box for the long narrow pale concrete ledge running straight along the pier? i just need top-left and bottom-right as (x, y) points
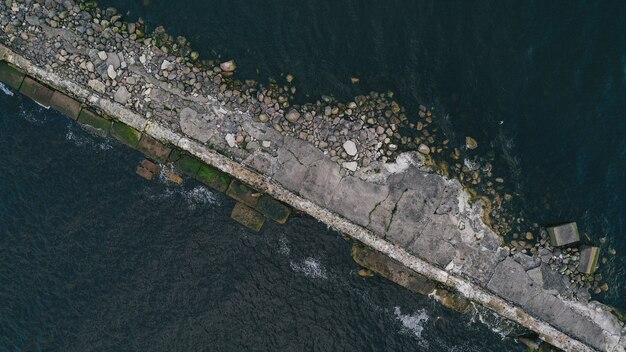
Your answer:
(0, 44), (600, 351)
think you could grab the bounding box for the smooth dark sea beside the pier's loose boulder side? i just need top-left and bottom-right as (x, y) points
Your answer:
(97, 0), (626, 310)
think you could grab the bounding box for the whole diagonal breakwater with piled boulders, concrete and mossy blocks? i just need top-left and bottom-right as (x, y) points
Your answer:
(0, 0), (626, 351)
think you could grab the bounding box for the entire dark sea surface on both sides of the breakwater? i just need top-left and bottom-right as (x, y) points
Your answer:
(0, 0), (626, 351)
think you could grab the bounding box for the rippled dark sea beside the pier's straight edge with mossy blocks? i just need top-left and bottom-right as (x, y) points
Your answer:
(0, 93), (522, 352)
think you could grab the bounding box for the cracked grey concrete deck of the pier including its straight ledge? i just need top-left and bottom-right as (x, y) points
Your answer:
(0, 20), (626, 351)
